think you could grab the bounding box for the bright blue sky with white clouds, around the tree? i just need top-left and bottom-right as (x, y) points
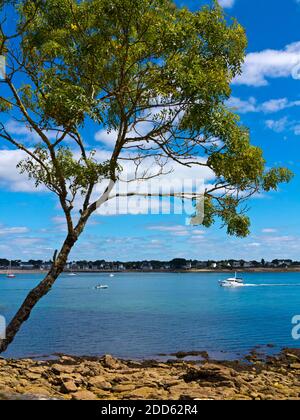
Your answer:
(0, 0), (300, 261)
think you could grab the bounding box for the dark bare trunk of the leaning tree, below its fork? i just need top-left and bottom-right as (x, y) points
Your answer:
(0, 235), (77, 353)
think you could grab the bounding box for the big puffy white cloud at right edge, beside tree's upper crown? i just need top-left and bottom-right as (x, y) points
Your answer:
(233, 42), (300, 86)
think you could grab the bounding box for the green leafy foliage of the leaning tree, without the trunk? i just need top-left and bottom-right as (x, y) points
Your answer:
(0, 0), (292, 236)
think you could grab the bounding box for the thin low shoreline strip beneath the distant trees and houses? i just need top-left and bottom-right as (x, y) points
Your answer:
(0, 267), (300, 276)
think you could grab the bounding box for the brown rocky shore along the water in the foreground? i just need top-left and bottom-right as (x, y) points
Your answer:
(0, 349), (300, 400)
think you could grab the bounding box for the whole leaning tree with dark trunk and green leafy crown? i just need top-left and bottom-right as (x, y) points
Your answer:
(0, 0), (291, 351)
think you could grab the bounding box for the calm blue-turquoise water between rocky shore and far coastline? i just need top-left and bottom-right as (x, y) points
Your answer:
(0, 273), (300, 358)
